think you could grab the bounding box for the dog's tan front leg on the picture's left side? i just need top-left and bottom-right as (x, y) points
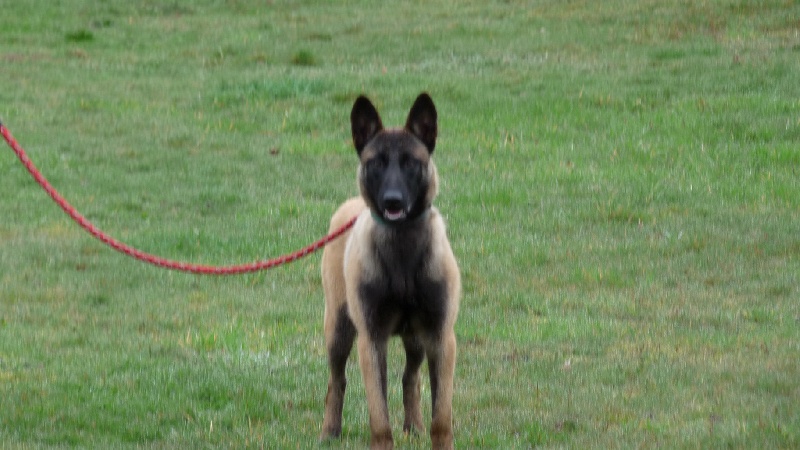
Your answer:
(358, 334), (394, 450)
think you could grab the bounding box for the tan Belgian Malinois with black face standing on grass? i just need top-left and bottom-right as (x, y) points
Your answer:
(322, 93), (461, 449)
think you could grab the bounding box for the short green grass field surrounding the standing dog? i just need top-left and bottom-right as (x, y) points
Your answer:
(0, 0), (800, 448)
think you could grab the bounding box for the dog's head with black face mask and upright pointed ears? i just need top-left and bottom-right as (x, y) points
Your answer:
(350, 93), (438, 225)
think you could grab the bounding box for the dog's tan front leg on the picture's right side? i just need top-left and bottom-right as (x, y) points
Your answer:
(428, 329), (456, 450)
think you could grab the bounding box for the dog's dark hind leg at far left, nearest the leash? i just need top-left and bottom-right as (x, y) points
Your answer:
(320, 305), (356, 439)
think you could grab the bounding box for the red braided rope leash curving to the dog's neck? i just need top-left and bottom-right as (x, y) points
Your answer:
(0, 123), (357, 275)
